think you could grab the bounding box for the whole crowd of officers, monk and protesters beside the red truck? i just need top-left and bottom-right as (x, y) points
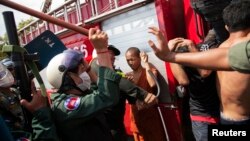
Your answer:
(0, 0), (250, 141)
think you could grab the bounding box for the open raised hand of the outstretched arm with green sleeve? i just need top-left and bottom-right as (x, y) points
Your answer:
(148, 27), (170, 61)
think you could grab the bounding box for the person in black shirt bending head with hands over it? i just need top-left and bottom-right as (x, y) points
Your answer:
(168, 38), (220, 141)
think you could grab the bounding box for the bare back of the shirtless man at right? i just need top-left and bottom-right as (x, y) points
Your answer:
(217, 33), (250, 121)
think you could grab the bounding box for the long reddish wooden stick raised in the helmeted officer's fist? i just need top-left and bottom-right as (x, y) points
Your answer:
(0, 0), (88, 35)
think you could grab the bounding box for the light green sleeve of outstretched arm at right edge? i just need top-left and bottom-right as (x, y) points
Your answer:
(229, 41), (250, 73)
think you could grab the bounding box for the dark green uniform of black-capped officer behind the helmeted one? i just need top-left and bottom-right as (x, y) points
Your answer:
(91, 59), (147, 141)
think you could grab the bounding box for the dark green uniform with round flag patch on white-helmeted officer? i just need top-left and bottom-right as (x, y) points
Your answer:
(51, 67), (121, 141)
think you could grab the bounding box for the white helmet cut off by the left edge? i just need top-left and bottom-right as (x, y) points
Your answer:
(0, 63), (14, 88)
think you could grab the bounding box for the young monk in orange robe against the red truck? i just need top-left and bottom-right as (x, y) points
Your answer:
(125, 47), (166, 141)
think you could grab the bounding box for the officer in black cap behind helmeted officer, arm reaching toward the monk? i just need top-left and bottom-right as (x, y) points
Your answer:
(90, 45), (157, 141)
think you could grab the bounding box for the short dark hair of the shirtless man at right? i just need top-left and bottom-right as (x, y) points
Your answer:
(223, 0), (250, 32)
